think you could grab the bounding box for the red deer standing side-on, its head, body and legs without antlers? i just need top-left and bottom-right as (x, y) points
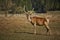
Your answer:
(26, 14), (51, 34)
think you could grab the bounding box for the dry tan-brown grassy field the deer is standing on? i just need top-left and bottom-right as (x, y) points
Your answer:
(0, 12), (60, 40)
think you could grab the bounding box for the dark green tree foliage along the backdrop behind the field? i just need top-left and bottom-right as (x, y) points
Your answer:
(0, 0), (60, 11)
